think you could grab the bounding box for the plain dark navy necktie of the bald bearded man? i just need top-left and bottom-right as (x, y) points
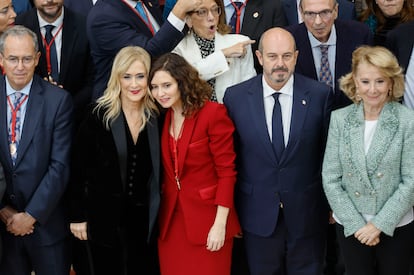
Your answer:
(272, 93), (285, 160)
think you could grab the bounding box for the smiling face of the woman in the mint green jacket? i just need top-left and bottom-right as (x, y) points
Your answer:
(354, 62), (392, 114)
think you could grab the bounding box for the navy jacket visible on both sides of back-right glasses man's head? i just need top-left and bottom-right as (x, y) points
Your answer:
(282, 0), (357, 25)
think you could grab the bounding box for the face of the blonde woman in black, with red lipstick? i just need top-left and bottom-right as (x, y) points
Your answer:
(119, 60), (148, 104)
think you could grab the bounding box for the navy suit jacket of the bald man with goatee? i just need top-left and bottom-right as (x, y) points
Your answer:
(224, 74), (332, 239)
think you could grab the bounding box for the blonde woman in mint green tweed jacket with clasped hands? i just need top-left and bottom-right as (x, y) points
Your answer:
(322, 46), (414, 275)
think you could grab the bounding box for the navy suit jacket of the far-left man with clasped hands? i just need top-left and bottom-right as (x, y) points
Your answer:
(0, 74), (72, 246)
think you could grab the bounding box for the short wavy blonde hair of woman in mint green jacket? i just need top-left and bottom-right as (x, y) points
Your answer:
(339, 46), (405, 103)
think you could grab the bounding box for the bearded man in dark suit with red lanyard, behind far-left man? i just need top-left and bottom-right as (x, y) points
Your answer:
(16, 0), (94, 127)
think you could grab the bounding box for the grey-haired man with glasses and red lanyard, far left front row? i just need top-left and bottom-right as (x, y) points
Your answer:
(0, 26), (73, 275)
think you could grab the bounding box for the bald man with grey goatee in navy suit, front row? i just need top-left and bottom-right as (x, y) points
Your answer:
(224, 28), (332, 275)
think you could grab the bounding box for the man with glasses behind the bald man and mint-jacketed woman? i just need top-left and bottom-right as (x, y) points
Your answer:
(287, 0), (372, 109)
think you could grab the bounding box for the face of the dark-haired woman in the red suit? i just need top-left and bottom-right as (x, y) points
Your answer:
(151, 70), (182, 109)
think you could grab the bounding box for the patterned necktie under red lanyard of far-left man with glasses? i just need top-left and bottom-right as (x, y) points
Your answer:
(9, 92), (23, 164)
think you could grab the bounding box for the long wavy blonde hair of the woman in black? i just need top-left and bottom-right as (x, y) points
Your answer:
(94, 46), (158, 131)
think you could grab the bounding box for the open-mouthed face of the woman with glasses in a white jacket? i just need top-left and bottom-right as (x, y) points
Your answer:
(187, 0), (221, 40)
